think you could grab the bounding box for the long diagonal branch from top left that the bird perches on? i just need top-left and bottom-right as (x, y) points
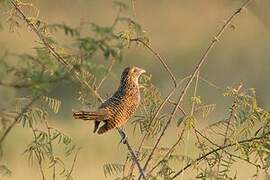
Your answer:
(11, 0), (145, 178)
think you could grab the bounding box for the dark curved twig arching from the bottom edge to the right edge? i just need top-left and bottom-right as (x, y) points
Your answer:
(171, 134), (269, 179)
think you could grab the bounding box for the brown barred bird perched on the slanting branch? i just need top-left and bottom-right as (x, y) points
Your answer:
(73, 67), (145, 134)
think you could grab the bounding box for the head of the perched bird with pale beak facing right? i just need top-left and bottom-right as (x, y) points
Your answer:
(121, 66), (146, 83)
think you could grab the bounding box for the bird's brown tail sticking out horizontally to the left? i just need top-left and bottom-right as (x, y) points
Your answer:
(73, 108), (109, 121)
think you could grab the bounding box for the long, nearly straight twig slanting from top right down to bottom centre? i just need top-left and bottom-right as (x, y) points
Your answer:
(139, 0), (251, 179)
